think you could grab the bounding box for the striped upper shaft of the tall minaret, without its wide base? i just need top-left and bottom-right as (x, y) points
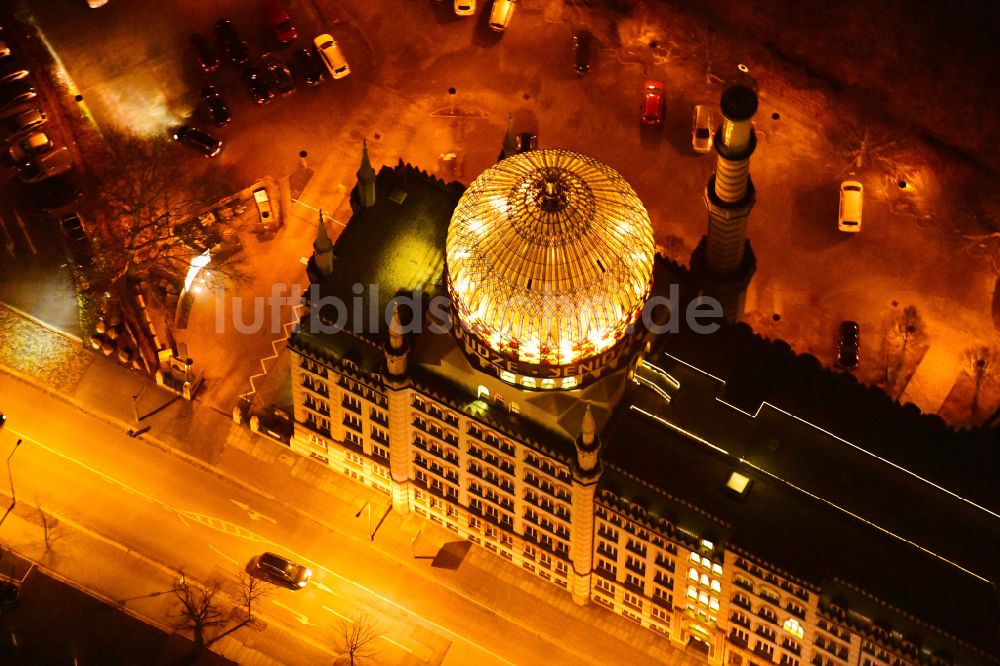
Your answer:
(705, 83), (757, 276)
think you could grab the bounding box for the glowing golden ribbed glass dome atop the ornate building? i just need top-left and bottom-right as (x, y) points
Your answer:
(447, 150), (654, 381)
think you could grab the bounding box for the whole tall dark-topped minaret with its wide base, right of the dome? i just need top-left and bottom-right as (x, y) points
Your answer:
(691, 76), (757, 322)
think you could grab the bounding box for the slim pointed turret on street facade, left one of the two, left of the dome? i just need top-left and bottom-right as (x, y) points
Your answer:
(383, 304), (413, 513)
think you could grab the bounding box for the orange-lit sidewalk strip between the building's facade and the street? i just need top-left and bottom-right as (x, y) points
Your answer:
(0, 308), (700, 664)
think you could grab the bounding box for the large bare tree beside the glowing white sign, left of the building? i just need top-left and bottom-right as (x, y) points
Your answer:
(91, 129), (244, 291)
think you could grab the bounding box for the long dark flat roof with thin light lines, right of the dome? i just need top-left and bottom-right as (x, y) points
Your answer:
(602, 348), (1000, 654)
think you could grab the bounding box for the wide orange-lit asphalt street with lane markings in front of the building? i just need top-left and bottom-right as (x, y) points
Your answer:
(0, 368), (708, 664)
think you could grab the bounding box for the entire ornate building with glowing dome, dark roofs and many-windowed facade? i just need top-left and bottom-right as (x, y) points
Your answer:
(289, 83), (1000, 666)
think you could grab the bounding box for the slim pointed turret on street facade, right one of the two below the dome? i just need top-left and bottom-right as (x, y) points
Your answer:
(569, 402), (604, 606)
